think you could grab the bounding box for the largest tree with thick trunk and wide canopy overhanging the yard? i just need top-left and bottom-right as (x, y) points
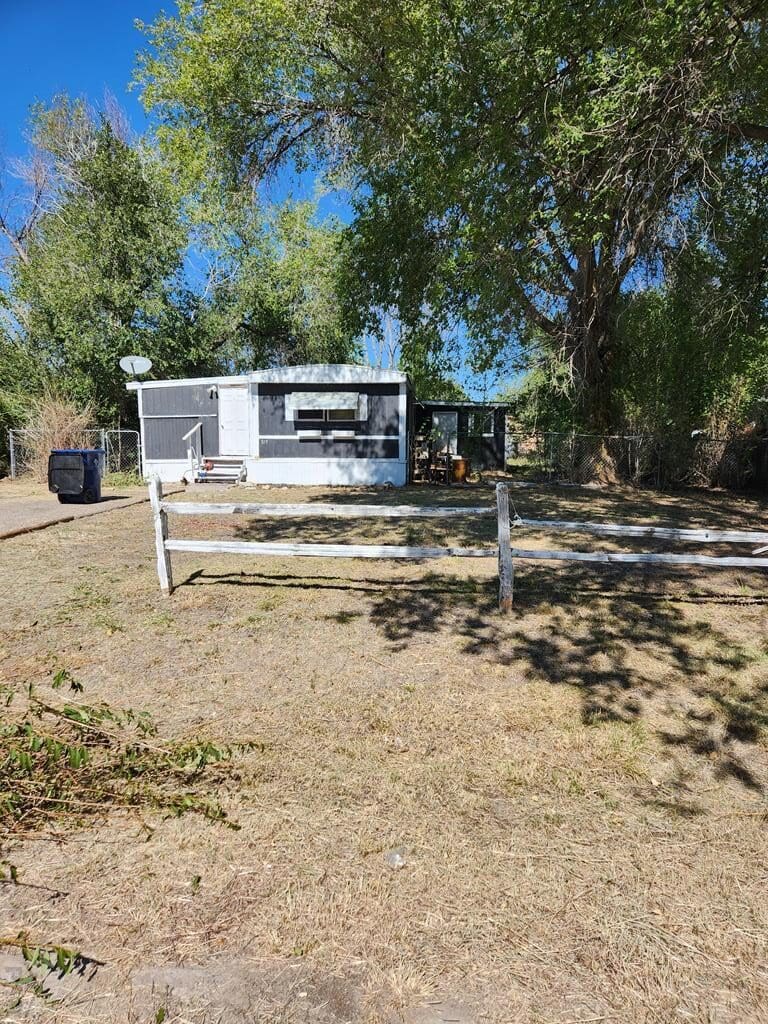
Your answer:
(140, 0), (768, 426)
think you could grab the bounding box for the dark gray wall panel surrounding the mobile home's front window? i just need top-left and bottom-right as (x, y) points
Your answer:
(258, 382), (399, 443)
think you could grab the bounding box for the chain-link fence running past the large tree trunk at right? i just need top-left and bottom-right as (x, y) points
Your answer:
(507, 432), (768, 490)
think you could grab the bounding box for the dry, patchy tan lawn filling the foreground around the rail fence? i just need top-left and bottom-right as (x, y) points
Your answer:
(0, 486), (768, 1024)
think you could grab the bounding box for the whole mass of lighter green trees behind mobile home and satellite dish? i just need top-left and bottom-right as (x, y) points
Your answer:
(0, 96), (359, 422)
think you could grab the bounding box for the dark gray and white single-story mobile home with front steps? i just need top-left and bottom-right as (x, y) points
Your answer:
(127, 364), (411, 485)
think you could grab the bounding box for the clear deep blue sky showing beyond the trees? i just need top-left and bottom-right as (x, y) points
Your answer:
(0, 0), (518, 397)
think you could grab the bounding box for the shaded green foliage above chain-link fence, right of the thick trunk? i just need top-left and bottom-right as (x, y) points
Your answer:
(614, 153), (768, 435)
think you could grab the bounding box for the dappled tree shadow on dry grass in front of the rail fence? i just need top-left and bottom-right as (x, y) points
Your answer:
(371, 566), (768, 792)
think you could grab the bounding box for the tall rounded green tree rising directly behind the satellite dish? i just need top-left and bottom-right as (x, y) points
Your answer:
(6, 98), (210, 422)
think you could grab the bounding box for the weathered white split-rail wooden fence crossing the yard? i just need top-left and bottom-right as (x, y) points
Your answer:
(150, 477), (768, 611)
